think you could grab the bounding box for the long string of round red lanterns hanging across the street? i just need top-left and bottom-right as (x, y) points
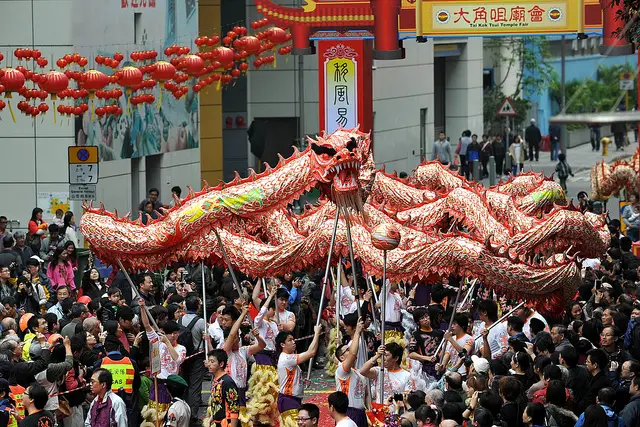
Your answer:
(0, 19), (292, 122)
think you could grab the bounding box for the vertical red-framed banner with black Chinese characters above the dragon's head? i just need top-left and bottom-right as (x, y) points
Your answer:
(318, 39), (373, 133)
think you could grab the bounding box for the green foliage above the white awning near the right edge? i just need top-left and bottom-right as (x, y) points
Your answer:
(549, 63), (637, 114)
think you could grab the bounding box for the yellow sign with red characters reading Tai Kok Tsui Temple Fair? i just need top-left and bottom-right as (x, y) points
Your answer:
(416, 0), (583, 36)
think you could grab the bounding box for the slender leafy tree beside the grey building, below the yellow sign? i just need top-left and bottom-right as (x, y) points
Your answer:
(483, 37), (556, 129)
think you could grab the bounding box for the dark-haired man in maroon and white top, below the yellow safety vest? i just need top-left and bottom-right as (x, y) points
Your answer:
(84, 369), (133, 427)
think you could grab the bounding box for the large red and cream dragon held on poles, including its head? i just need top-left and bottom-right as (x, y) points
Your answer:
(80, 129), (609, 298)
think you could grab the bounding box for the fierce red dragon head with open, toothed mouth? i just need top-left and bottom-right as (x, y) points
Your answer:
(307, 127), (371, 211)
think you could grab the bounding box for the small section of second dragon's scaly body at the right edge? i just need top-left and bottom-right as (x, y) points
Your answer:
(591, 151), (640, 200)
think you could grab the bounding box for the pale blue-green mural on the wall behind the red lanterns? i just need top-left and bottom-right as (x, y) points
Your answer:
(74, 0), (199, 161)
